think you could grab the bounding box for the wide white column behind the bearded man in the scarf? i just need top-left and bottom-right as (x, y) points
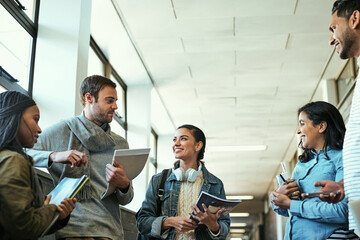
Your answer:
(33, 0), (91, 128)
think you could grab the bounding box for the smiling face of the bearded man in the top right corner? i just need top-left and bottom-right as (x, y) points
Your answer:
(329, 11), (356, 59)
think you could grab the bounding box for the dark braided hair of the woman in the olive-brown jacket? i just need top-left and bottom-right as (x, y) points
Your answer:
(0, 91), (36, 156)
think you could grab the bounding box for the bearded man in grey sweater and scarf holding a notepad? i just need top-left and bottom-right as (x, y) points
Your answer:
(28, 75), (134, 240)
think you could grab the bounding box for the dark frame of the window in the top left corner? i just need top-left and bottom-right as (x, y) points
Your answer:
(0, 0), (40, 97)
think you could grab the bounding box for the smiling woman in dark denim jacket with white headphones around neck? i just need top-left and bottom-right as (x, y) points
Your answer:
(137, 125), (230, 240)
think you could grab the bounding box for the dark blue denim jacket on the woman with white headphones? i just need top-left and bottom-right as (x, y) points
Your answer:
(137, 165), (230, 240)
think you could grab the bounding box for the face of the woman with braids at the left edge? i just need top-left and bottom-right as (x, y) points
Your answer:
(16, 105), (41, 148)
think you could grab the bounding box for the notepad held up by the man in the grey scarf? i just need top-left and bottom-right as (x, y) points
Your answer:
(100, 148), (150, 199)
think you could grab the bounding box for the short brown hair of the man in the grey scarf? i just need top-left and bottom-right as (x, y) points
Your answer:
(80, 75), (116, 106)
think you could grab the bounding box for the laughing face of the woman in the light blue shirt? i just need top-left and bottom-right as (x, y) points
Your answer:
(297, 112), (327, 152)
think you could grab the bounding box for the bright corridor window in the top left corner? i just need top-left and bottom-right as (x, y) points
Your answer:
(0, 0), (38, 95)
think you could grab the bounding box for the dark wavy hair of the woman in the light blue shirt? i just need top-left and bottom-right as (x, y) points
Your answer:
(298, 101), (346, 162)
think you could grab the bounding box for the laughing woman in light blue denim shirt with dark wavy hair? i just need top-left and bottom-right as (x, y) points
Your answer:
(270, 101), (348, 240)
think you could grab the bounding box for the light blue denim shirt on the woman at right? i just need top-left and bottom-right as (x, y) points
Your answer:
(272, 147), (348, 240)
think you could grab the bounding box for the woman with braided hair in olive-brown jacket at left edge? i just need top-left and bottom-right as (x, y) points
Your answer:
(0, 91), (76, 240)
